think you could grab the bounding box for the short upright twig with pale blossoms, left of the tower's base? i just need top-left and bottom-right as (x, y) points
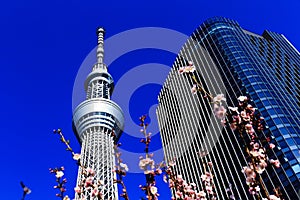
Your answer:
(49, 167), (70, 200)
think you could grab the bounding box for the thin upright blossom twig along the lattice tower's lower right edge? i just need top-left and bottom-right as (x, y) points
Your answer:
(114, 143), (129, 200)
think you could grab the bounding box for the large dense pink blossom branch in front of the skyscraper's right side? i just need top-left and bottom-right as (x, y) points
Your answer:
(214, 95), (280, 198)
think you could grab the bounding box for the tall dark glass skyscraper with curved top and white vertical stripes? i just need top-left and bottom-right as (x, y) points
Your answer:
(157, 17), (300, 200)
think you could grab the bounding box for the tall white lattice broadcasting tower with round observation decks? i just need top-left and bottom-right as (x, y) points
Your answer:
(73, 28), (124, 200)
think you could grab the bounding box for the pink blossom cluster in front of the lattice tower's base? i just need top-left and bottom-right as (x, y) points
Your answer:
(74, 167), (104, 200)
